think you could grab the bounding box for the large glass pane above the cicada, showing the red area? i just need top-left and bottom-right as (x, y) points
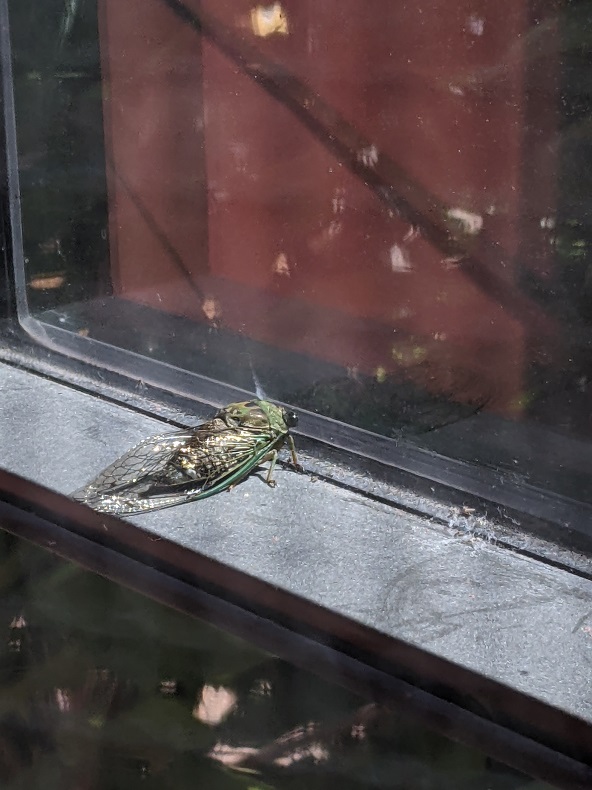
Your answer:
(9, 0), (592, 502)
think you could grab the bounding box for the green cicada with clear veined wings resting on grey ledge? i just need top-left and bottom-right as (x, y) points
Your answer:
(71, 400), (301, 516)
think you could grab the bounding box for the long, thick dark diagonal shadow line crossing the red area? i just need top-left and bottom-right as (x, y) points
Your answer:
(160, 0), (549, 334)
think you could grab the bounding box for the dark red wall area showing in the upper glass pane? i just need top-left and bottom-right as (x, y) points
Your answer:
(97, 0), (554, 411)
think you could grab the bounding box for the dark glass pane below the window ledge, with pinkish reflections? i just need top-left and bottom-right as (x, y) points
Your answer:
(0, 532), (550, 790)
